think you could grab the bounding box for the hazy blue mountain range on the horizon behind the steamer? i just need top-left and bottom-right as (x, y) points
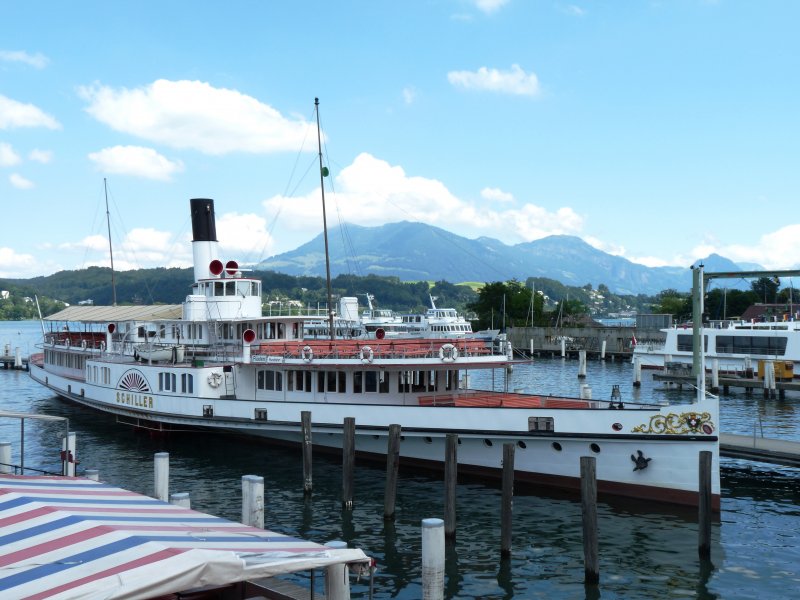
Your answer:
(257, 221), (762, 295)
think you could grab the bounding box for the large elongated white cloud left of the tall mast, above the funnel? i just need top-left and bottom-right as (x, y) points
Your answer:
(79, 79), (316, 155)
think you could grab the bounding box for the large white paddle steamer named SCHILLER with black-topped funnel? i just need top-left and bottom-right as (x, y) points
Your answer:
(30, 199), (720, 507)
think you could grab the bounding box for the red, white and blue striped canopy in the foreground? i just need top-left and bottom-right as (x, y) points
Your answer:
(0, 475), (369, 599)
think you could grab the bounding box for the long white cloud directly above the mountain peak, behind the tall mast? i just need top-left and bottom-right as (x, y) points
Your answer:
(264, 153), (583, 250)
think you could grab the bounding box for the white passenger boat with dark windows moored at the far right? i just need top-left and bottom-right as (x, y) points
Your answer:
(633, 321), (800, 373)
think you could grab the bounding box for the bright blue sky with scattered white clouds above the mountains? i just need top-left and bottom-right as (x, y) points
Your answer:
(0, 0), (800, 278)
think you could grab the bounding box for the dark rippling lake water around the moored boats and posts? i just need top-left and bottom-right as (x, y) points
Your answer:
(0, 322), (800, 599)
